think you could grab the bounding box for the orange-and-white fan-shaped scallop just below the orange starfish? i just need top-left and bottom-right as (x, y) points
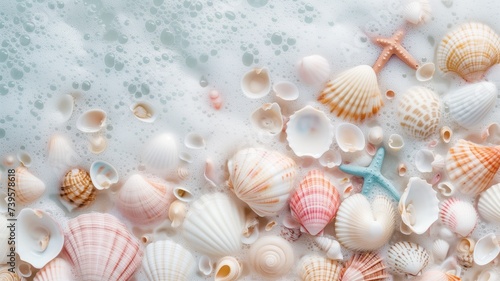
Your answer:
(318, 65), (383, 121)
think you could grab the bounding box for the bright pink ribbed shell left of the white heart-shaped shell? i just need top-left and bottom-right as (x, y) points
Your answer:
(290, 170), (340, 235)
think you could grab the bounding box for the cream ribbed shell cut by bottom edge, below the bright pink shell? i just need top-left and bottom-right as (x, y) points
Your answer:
(299, 255), (342, 281)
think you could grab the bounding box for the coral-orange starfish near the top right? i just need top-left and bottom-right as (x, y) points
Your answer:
(373, 29), (418, 73)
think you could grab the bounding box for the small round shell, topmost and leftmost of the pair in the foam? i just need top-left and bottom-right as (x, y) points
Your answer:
(241, 67), (271, 99)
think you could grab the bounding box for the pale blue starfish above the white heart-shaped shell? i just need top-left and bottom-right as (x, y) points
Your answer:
(339, 147), (399, 199)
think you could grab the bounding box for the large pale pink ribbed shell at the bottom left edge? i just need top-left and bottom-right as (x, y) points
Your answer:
(64, 213), (142, 281)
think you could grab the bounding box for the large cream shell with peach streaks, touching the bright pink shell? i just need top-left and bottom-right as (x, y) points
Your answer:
(227, 148), (297, 217)
